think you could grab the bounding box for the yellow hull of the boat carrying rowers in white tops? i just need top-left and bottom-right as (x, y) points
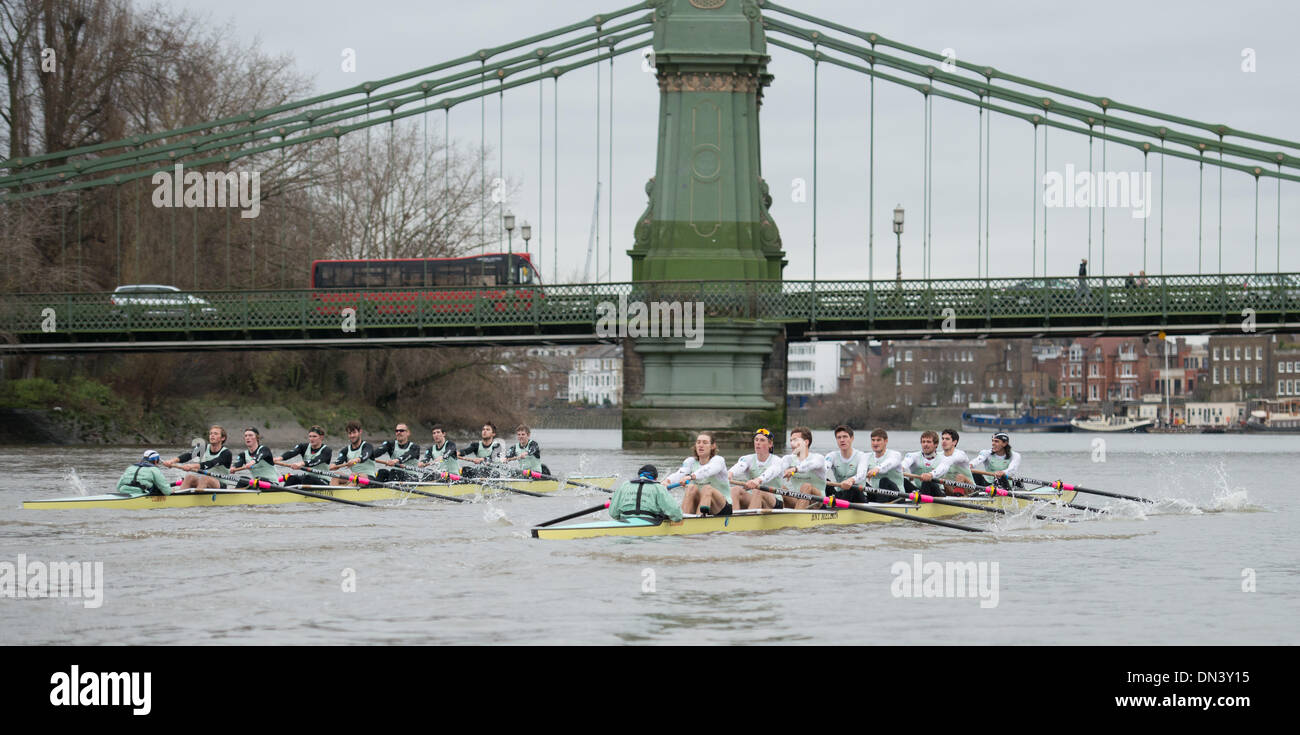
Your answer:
(533, 488), (1076, 540)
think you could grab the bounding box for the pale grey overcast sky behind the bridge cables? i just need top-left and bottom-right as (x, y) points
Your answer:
(157, 0), (1300, 280)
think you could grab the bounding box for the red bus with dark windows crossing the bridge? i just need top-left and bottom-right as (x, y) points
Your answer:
(312, 252), (541, 316)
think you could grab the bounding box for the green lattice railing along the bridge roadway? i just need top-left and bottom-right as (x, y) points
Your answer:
(0, 273), (1300, 336)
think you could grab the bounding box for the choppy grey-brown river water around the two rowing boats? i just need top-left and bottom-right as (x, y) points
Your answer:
(0, 429), (1300, 645)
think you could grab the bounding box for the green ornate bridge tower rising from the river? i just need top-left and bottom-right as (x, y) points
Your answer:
(623, 0), (785, 449)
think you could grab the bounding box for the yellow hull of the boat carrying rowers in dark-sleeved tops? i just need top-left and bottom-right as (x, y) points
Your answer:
(22, 475), (615, 510)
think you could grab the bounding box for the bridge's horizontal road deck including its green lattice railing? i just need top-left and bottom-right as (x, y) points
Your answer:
(0, 273), (1300, 353)
